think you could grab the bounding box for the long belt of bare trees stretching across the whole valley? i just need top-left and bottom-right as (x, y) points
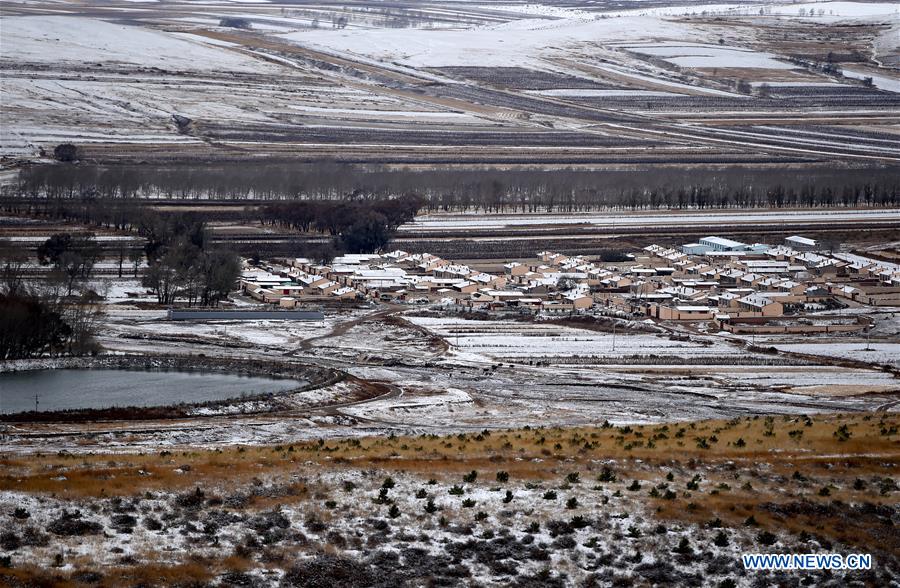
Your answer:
(3, 162), (900, 211)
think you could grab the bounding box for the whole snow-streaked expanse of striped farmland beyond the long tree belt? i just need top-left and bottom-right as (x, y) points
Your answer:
(0, 0), (900, 166)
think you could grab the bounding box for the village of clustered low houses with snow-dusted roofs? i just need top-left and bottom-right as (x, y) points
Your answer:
(240, 236), (900, 333)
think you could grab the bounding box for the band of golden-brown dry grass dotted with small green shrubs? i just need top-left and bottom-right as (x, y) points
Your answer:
(0, 413), (900, 498)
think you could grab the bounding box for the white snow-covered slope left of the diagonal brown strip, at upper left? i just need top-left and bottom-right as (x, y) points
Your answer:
(0, 15), (492, 155)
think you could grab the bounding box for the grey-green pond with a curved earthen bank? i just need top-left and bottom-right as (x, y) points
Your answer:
(0, 369), (306, 414)
